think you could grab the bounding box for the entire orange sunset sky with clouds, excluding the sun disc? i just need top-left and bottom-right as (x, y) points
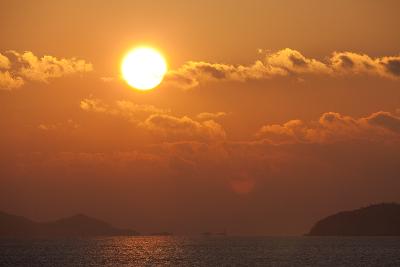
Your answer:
(0, 0), (400, 235)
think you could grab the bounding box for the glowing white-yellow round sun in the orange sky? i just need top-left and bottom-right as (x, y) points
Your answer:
(121, 47), (167, 91)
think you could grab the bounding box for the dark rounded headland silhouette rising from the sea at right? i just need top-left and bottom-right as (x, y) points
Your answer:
(308, 203), (400, 236)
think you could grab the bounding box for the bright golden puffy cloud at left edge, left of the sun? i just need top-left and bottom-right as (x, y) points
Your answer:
(0, 51), (93, 90)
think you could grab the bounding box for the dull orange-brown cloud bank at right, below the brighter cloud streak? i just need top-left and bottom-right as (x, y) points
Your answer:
(257, 111), (400, 144)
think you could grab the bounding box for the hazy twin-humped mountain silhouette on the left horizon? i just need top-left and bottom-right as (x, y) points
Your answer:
(0, 212), (138, 238)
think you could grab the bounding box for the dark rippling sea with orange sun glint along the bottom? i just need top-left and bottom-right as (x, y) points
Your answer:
(0, 236), (400, 266)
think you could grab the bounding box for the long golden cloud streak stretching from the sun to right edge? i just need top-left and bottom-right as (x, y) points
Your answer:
(166, 48), (400, 89)
